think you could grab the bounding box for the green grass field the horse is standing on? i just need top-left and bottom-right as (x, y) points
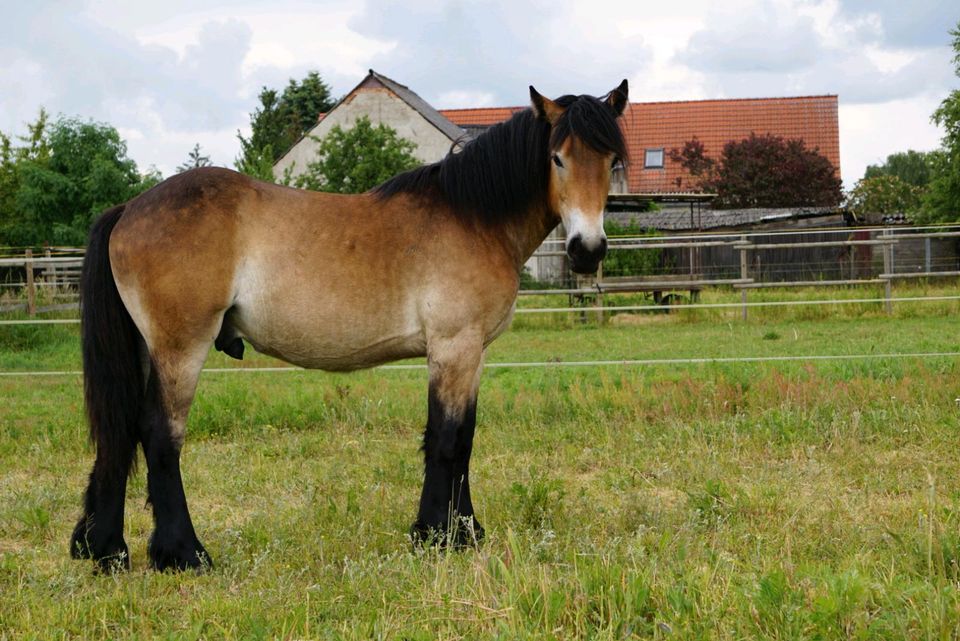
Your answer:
(0, 302), (960, 639)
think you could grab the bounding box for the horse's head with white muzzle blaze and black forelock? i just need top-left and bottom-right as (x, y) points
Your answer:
(530, 80), (627, 274)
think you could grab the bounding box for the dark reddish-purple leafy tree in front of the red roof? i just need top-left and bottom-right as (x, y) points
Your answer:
(702, 133), (842, 209)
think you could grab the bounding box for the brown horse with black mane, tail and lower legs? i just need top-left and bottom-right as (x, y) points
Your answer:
(70, 80), (628, 571)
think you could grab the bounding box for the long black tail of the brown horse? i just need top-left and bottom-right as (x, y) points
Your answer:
(80, 205), (145, 482)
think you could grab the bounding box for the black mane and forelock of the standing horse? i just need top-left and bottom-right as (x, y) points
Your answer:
(373, 95), (627, 223)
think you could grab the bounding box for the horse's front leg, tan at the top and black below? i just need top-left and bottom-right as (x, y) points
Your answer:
(411, 332), (483, 547)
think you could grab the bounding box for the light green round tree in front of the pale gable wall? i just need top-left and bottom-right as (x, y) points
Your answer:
(293, 116), (420, 194)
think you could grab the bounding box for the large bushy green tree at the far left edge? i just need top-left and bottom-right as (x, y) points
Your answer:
(0, 111), (160, 246)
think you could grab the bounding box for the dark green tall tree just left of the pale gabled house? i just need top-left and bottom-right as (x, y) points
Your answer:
(234, 71), (334, 181)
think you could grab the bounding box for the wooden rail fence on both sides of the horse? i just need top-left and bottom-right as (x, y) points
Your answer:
(0, 225), (960, 319)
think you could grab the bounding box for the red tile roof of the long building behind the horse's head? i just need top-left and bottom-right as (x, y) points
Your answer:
(440, 95), (840, 193)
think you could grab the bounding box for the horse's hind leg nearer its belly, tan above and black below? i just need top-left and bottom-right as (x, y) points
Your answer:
(141, 340), (212, 571)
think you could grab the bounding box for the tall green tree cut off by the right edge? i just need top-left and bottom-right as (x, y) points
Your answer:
(916, 22), (960, 223)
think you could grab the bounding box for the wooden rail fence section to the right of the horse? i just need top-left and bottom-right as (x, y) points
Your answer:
(520, 227), (960, 319)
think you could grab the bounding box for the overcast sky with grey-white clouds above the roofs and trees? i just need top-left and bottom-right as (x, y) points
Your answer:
(0, 0), (960, 188)
